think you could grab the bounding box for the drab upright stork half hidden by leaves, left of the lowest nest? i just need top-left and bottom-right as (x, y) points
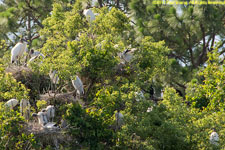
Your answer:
(20, 99), (30, 120)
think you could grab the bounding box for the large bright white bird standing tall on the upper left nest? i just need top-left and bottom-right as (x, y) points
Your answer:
(11, 39), (27, 63)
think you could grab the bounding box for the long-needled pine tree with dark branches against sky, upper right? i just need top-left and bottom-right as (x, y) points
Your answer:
(130, 0), (225, 94)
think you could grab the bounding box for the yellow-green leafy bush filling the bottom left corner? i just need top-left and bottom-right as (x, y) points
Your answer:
(0, 103), (38, 150)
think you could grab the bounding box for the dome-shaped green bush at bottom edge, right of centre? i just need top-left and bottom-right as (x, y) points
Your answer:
(118, 88), (188, 149)
